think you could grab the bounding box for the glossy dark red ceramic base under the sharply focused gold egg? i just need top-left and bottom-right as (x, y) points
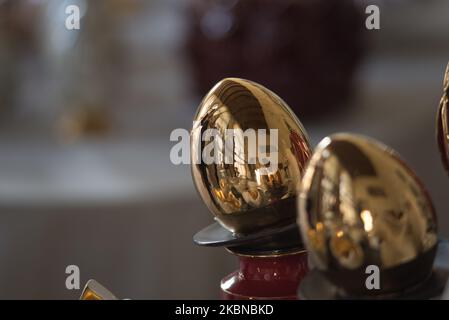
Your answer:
(221, 251), (308, 300)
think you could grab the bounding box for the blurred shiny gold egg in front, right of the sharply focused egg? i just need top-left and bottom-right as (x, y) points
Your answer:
(298, 134), (437, 295)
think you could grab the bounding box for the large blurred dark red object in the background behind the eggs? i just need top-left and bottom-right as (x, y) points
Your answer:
(187, 0), (366, 119)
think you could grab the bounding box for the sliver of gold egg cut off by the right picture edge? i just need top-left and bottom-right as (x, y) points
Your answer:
(437, 64), (449, 174)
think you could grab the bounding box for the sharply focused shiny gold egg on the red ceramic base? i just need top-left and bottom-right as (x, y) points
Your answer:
(191, 78), (311, 234)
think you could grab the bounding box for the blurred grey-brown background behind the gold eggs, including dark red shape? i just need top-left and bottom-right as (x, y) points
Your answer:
(0, 0), (449, 299)
